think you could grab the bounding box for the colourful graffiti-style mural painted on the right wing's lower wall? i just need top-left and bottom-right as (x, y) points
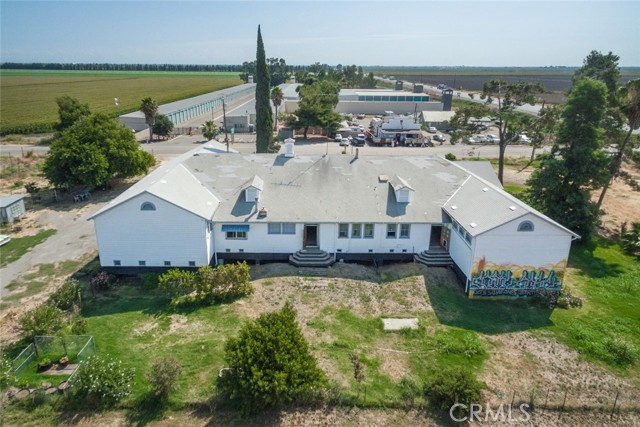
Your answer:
(469, 257), (566, 297)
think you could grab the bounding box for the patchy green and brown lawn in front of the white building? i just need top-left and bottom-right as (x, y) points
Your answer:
(2, 239), (640, 421)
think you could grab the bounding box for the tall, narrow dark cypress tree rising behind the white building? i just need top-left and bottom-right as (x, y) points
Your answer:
(256, 25), (273, 153)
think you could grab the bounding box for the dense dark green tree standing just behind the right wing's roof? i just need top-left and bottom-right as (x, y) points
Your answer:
(527, 79), (609, 240)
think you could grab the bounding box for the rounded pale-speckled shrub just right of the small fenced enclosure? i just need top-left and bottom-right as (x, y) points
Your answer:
(73, 356), (135, 408)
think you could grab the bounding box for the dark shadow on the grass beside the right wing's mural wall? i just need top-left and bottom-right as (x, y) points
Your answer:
(424, 269), (553, 335)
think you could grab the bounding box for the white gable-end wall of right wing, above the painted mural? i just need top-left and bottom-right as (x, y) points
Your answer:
(474, 215), (571, 267)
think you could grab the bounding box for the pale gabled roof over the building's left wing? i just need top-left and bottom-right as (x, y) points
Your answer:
(89, 164), (220, 220)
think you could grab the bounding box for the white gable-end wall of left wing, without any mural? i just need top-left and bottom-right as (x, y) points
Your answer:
(94, 193), (211, 267)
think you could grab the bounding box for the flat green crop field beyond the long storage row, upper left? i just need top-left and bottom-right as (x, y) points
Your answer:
(0, 70), (242, 134)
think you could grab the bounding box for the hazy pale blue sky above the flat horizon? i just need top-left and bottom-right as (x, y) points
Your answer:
(0, 0), (640, 67)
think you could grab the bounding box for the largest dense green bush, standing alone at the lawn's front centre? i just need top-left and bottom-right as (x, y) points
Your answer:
(218, 303), (325, 413)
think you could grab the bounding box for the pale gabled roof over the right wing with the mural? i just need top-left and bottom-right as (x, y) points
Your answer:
(442, 162), (580, 239)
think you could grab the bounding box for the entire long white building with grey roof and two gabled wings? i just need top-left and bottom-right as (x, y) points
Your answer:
(91, 146), (578, 297)
